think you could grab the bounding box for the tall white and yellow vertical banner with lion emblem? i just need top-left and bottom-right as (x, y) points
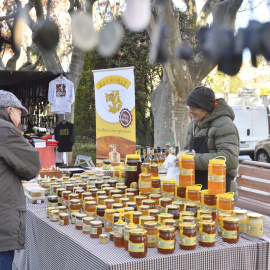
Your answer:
(93, 67), (136, 166)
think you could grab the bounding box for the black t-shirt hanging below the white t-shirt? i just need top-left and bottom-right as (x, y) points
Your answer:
(54, 120), (75, 152)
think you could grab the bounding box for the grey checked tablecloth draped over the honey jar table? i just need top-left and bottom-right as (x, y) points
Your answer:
(13, 204), (270, 270)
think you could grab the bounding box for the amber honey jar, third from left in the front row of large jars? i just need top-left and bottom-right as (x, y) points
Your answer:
(179, 223), (197, 250)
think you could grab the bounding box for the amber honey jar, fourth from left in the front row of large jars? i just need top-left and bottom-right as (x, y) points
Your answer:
(198, 221), (216, 247)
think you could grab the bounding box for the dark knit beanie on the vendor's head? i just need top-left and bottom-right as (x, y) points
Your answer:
(186, 86), (216, 112)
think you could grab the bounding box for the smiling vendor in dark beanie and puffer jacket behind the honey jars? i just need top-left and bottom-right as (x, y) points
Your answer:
(184, 86), (239, 192)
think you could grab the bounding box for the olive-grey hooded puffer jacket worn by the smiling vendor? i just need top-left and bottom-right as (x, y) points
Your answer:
(185, 98), (239, 177)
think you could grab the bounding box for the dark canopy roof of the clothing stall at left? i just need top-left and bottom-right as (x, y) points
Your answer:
(0, 70), (65, 91)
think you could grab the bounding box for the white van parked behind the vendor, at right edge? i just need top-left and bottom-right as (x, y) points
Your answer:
(232, 106), (270, 159)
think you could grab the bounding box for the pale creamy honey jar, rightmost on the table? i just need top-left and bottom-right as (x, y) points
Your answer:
(246, 213), (263, 238)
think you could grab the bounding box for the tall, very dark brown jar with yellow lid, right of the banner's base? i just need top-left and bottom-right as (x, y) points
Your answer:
(125, 155), (142, 187)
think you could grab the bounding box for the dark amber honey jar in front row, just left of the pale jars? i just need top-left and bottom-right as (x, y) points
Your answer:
(222, 217), (239, 244)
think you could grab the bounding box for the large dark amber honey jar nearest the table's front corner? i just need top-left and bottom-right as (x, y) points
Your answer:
(128, 229), (147, 258)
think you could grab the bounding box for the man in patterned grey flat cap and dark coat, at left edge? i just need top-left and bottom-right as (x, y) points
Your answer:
(0, 90), (41, 270)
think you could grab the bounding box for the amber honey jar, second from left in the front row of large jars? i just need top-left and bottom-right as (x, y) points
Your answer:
(157, 225), (175, 254)
